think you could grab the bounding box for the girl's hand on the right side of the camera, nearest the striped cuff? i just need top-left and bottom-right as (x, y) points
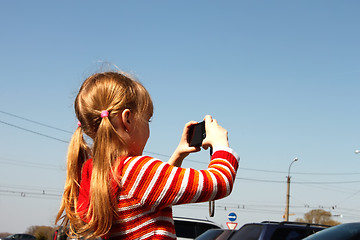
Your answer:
(202, 115), (229, 149)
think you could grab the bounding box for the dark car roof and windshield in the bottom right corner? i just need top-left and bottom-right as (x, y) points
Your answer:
(304, 222), (360, 240)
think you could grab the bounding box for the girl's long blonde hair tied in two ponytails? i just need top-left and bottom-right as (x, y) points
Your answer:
(56, 72), (153, 238)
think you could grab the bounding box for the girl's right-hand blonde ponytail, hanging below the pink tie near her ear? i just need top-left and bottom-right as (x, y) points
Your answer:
(88, 114), (127, 236)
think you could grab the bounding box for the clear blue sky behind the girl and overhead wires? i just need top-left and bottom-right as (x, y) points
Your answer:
(0, 0), (360, 233)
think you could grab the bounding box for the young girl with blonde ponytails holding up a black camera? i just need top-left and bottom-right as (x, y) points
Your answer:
(56, 72), (239, 239)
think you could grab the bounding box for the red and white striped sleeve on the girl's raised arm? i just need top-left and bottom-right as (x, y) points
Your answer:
(122, 147), (239, 209)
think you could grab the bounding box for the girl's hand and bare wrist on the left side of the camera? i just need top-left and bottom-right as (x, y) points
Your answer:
(168, 121), (201, 167)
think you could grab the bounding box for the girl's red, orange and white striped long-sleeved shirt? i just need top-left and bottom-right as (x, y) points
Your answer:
(79, 148), (239, 239)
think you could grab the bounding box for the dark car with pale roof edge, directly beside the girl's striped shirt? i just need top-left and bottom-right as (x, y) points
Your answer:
(173, 217), (221, 240)
